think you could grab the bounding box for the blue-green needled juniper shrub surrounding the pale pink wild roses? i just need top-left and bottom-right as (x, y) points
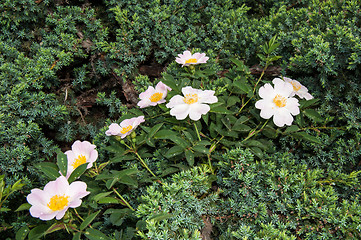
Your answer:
(0, 0), (361, 239)
